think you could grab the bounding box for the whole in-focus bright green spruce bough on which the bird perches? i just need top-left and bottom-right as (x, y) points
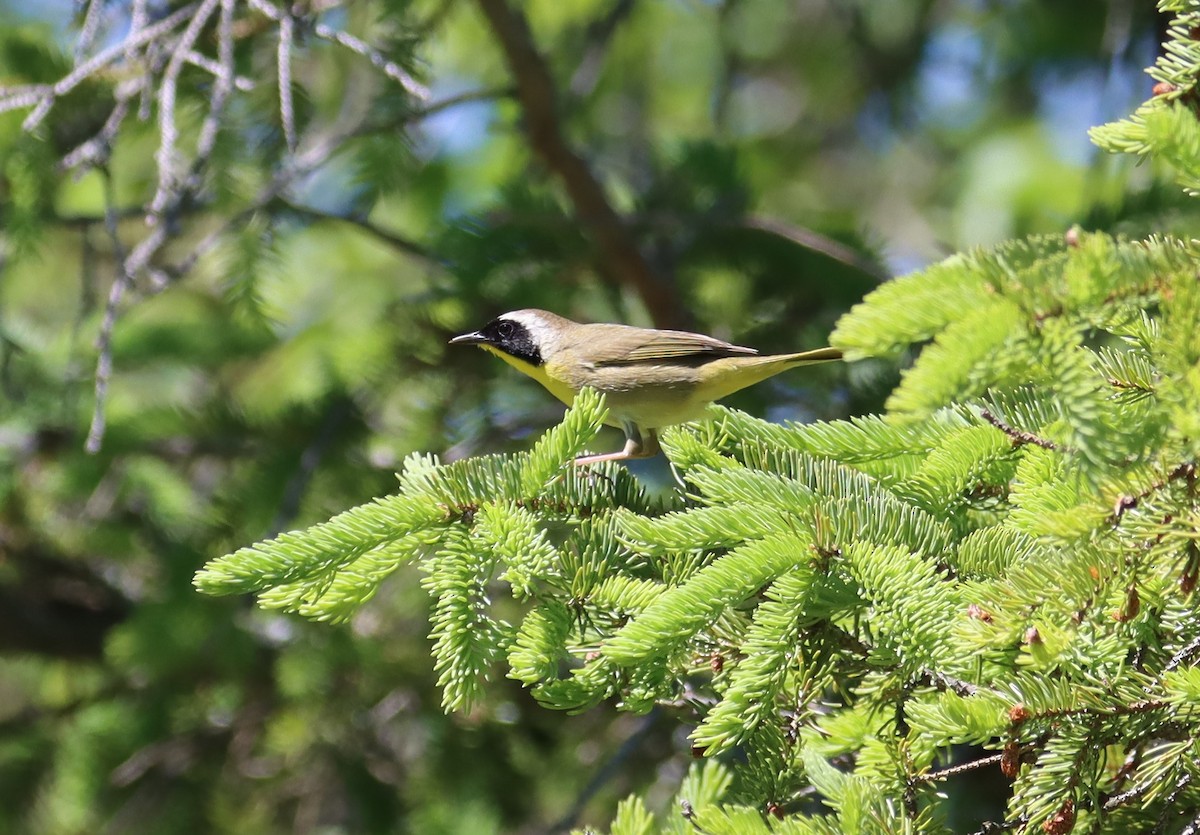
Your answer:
(166, 8), (1200, 831)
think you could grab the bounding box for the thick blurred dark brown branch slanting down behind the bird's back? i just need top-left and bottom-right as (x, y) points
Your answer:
(479, 0), (684, 326)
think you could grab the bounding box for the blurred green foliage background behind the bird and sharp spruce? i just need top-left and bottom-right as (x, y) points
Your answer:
(0, 0), (1188, 833)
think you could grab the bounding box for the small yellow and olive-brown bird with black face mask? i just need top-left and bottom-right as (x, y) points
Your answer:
(450, 310), (841, 464)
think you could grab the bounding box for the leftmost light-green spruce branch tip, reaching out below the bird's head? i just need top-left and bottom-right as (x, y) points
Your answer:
(194, 390), (633, 614)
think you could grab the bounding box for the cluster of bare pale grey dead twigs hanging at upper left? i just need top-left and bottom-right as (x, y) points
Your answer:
(0, 0), (446, 452)
